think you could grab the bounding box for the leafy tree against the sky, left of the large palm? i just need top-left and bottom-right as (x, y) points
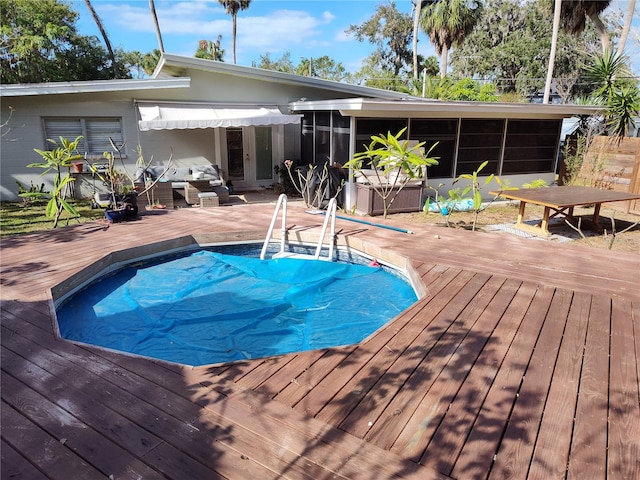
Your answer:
(346, 1), (413, 77)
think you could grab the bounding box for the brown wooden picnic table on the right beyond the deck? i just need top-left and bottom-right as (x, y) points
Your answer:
(489, 185), (640, 236)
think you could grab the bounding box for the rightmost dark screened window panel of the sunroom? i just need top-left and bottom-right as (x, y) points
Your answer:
(502, 120), (562, 175)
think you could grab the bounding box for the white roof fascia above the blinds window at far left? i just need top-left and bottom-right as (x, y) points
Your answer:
(0, 78), (191, 97)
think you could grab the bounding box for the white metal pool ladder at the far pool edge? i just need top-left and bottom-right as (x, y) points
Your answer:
(260, 193), (337, 262)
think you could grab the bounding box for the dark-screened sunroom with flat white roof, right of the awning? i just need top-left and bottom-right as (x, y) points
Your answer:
(289, 97), (595, 211)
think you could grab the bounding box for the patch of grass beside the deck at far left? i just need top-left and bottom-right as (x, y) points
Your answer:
(0, 200), (104, 237)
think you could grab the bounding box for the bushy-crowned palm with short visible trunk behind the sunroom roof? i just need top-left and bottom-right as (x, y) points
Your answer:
(421, 0), (481, 78)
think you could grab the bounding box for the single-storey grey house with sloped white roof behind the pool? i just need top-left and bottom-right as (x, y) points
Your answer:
(0, 54), (593, 206)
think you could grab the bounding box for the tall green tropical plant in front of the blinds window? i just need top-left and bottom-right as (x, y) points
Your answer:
(27, 136), (83, 228)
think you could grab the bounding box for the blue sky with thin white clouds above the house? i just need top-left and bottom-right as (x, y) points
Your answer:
(72, 0), (640, 74)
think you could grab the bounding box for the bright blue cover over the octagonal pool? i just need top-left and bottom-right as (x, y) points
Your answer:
(57, 251), (416, 365)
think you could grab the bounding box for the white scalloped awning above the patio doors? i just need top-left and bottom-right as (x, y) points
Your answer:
(137, 103), (302, 132)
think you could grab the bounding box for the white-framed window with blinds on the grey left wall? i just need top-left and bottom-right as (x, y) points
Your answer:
(44, 117), (124, 157)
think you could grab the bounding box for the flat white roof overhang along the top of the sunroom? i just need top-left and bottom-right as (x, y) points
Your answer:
(289, 97), (600, 119)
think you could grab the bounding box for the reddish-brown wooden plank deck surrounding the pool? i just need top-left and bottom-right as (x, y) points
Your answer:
(1, 200), (640, 480)
